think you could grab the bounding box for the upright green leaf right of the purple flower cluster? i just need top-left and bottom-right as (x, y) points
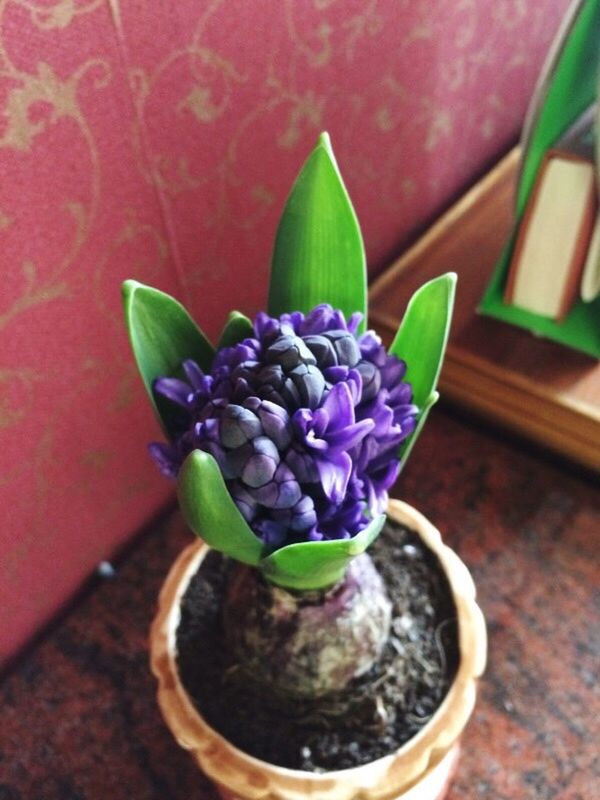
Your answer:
(389, 272), (456, 462)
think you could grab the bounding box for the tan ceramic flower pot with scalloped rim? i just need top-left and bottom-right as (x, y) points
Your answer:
(150, 500), (486, 800)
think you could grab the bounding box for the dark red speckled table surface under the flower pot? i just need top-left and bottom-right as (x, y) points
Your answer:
(0, 408), (600, 800)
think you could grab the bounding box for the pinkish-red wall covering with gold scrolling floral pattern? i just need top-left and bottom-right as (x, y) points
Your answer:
(0, 0), (567, 660)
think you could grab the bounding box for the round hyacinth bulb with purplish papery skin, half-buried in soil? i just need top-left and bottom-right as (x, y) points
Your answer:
(223, 553), (392, 700)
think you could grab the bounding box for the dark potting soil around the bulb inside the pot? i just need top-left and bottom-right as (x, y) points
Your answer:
(177, 521), (458, 771)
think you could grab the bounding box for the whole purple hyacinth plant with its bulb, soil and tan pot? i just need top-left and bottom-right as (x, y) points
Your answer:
(124, 134), (485, 800)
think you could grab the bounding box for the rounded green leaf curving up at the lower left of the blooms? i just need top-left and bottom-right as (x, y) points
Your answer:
(177, 450), (263, 566)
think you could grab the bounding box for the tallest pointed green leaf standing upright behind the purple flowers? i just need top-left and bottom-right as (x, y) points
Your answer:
(268, 133), (367, 332)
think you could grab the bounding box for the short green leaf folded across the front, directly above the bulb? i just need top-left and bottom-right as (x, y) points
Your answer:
(259, 514), (385, 591)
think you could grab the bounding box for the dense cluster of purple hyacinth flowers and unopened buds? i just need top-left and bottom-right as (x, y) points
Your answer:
(150, 305), (417, 548)
